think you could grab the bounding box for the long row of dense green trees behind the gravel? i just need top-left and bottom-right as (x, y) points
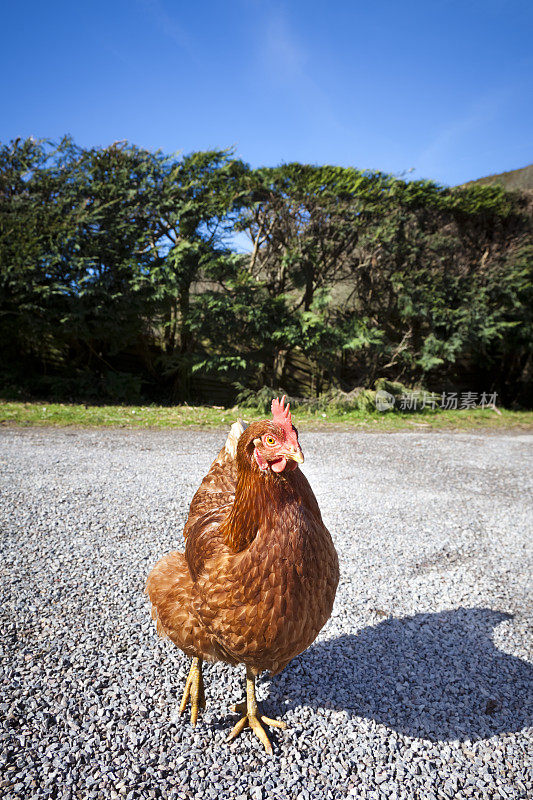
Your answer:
(0, 138), (533, 404)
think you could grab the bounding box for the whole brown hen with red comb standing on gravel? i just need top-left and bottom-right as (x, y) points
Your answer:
(146, 398), (339, 753)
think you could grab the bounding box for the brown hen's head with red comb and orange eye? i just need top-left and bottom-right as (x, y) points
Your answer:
(237, 396), (304, 475)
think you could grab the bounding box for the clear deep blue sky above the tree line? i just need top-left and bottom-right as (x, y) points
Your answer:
(0, 0), (533, 184)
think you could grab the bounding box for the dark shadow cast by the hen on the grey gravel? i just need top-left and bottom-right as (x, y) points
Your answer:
(270, 608), (533, 741)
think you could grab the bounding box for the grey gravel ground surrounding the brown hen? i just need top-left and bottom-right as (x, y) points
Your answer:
(0, 428), (533, 800)
